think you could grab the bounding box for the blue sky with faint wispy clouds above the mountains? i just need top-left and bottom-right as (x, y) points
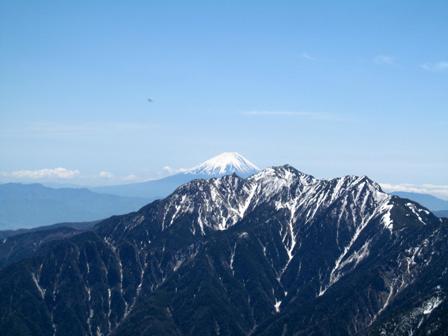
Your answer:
(0, 0), (448, 197)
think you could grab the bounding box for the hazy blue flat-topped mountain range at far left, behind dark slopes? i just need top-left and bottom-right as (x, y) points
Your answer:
(0, 183), (148, 230)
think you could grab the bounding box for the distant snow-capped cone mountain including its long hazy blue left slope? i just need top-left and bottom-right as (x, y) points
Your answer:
(91, 152), (259, 201)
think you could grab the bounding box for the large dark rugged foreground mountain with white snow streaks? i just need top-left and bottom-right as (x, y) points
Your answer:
(0, 165), (448, 336)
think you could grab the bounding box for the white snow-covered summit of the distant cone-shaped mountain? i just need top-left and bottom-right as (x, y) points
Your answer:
(187, 152), (259, 177)
